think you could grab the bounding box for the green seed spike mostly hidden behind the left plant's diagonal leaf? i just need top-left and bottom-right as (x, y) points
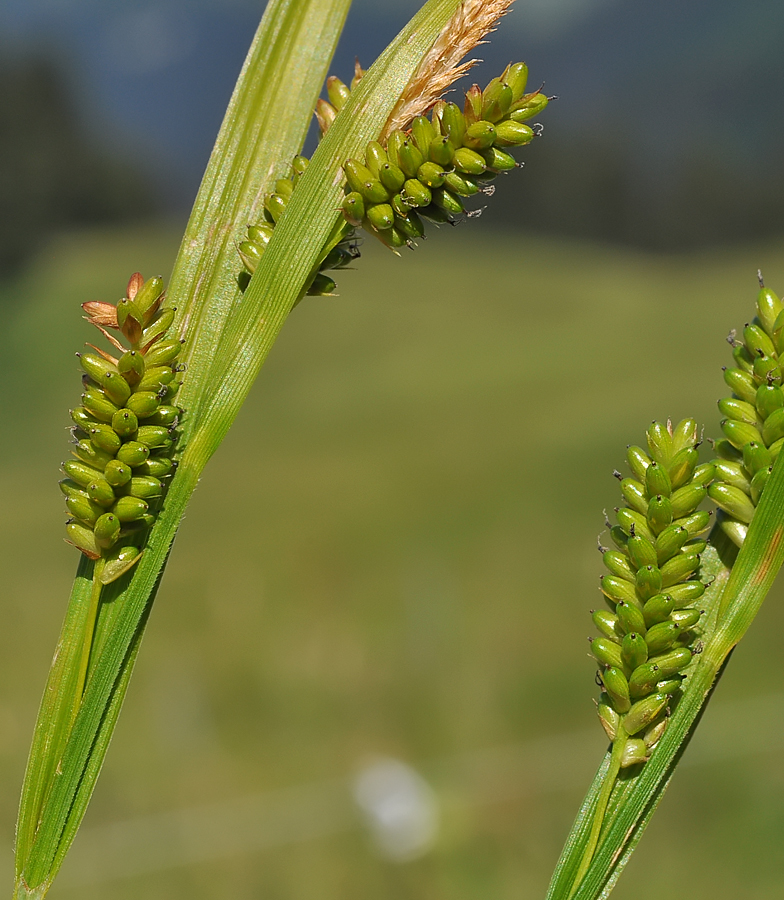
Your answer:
(237, 156), (359, 297)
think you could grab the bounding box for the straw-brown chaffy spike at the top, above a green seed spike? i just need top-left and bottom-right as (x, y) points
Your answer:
(381, 0), (514, 141)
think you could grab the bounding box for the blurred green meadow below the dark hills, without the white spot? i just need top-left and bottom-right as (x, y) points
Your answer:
(0, 226), (784, 900)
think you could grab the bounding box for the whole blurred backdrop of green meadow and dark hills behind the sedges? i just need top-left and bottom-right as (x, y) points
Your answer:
(0, 0), (784, 900)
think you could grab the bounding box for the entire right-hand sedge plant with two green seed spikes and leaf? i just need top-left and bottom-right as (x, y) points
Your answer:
(547, 273), (784, 900)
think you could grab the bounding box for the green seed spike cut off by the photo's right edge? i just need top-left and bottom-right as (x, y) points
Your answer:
(708, 277), (784, 547)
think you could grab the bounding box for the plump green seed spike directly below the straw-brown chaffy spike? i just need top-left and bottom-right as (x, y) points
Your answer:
(340, 63), (549, 250)
